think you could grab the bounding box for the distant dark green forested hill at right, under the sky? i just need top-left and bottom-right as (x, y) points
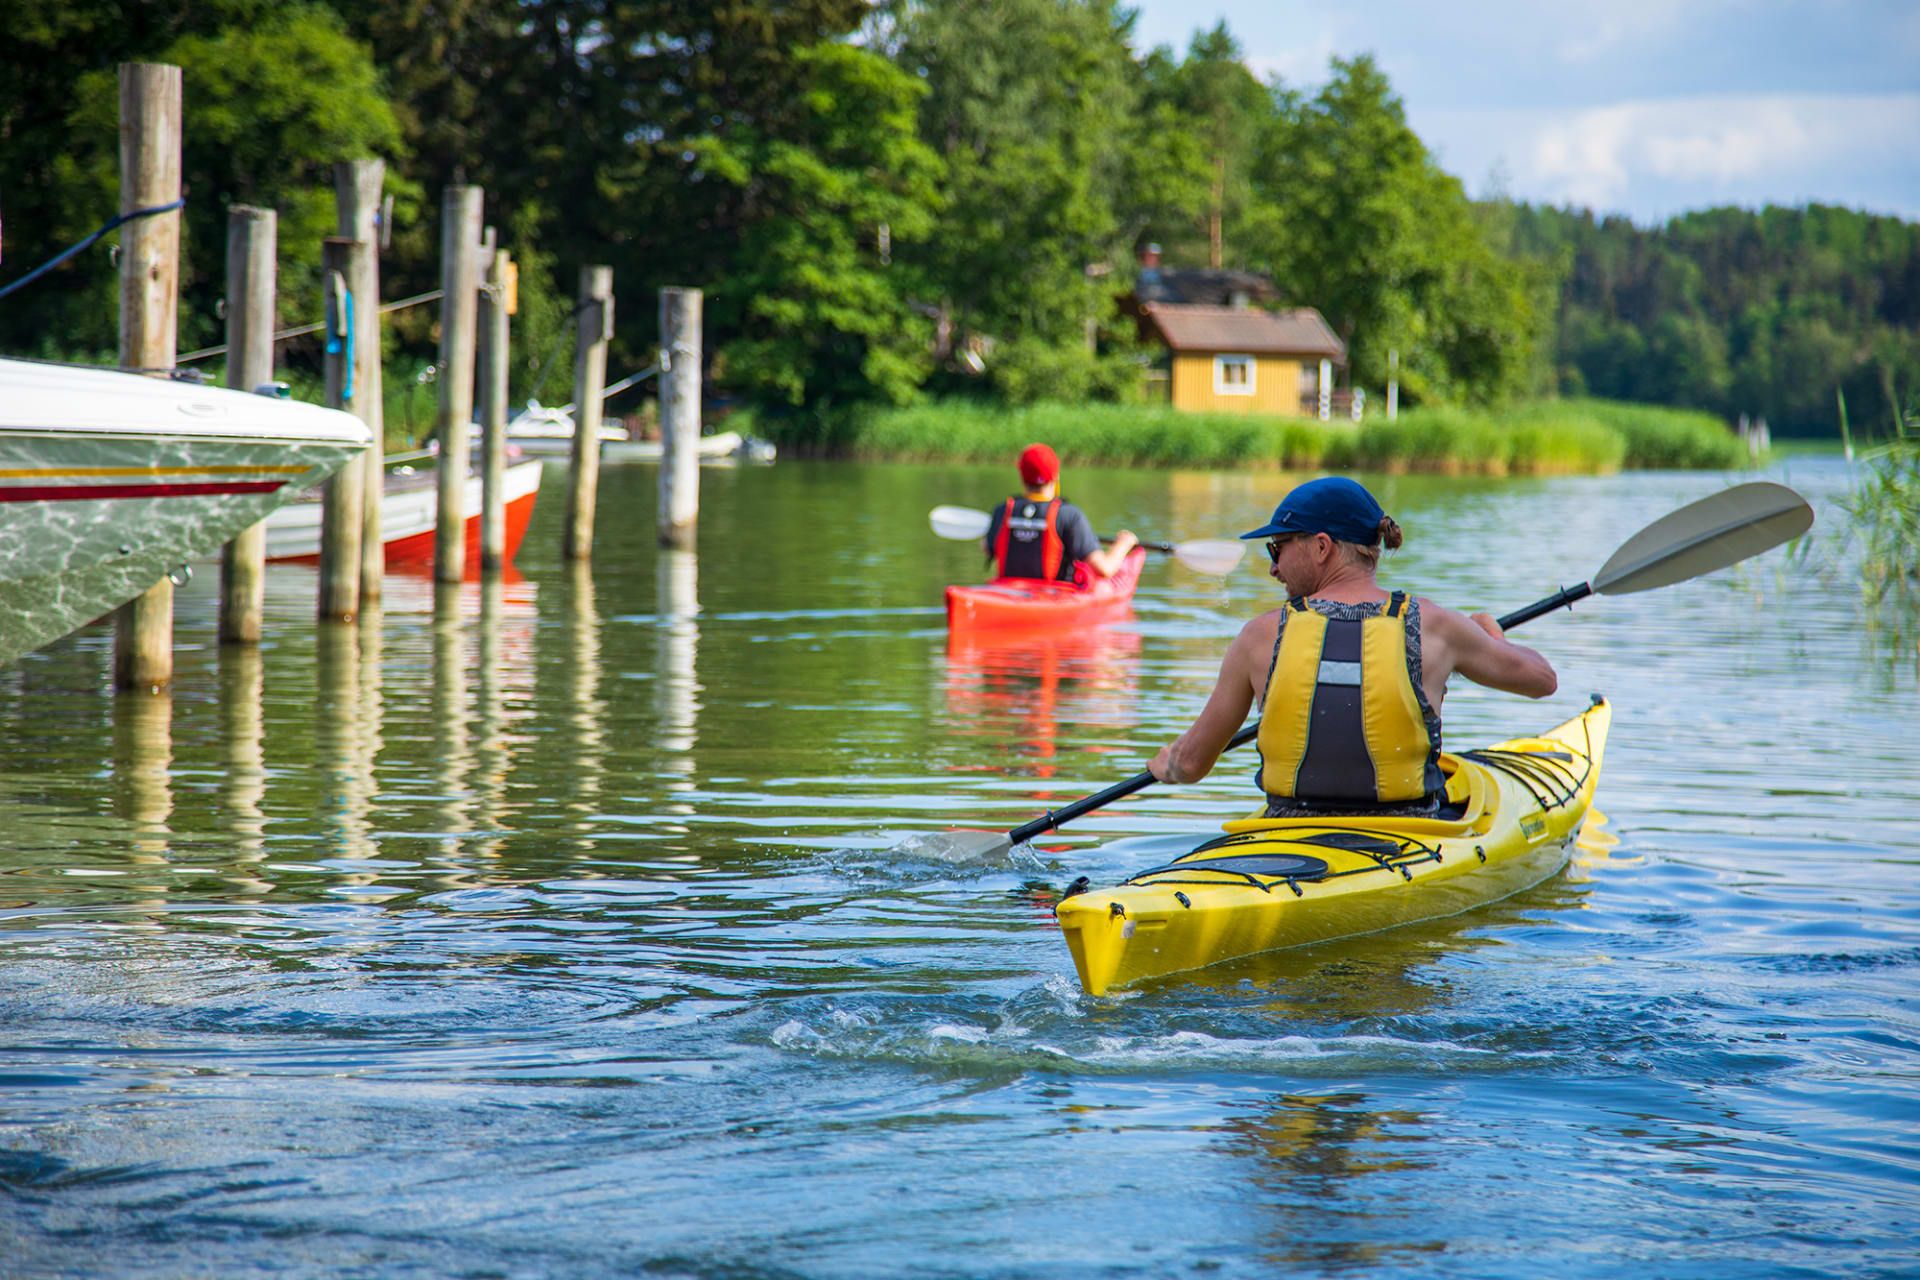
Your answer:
(1509, 205), (1920, 436)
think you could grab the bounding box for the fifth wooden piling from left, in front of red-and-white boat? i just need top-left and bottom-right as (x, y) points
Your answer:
(434, 186), (482, 581)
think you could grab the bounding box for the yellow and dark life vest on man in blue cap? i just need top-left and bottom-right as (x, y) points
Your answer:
(1256, 591), (1446, 806)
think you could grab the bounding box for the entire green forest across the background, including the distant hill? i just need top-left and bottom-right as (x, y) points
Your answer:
(0, 0), (1920, 434)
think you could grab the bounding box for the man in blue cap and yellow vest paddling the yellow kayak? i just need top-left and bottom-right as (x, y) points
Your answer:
(1146, 476), (1559, 818)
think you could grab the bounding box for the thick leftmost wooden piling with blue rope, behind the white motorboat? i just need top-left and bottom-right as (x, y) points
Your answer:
(113, 61), (180, 691)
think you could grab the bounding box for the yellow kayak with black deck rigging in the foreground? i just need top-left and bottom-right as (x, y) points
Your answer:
(1056, 697), (1613, 996)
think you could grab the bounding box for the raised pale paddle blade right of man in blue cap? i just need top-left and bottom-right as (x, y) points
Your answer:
(1594, 480), (1812, 595)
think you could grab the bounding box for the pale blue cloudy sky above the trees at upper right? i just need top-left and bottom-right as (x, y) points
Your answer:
(1121, 0), (1920, 225)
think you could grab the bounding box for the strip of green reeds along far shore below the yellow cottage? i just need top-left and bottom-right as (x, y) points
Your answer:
(752, 399), (1753, 476)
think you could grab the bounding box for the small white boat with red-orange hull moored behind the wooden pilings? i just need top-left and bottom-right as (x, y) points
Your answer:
(267, 455), (543, 568)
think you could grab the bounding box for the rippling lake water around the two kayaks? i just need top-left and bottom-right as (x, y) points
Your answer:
(0, 459), (1920, 1280)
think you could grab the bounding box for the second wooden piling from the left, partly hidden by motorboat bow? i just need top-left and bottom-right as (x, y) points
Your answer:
(221, 205), (278, 645)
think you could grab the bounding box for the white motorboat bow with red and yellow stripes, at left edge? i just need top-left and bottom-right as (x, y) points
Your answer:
(0, 359), (369, 662)
